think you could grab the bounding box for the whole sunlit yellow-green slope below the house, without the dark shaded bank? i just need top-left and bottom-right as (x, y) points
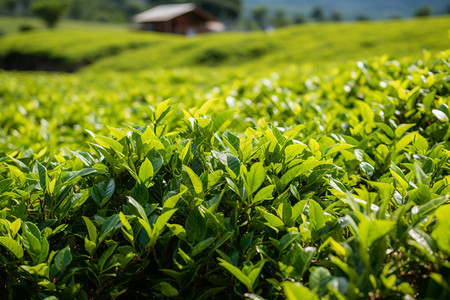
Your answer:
(0, 17), (450, 72)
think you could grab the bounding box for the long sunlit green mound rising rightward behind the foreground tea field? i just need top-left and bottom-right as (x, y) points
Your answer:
(86, 17), (449, 72)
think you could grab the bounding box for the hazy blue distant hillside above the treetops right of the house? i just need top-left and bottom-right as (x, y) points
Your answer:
(244, 0), (450, 20)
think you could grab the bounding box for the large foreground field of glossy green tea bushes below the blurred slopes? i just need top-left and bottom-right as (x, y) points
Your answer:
(0, 15), (450, 300)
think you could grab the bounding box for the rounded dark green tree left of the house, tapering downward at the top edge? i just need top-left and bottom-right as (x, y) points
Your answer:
(31, 0), (69, 28)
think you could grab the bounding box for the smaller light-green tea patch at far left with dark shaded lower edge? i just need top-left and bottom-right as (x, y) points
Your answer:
(0, 29), (177, 71)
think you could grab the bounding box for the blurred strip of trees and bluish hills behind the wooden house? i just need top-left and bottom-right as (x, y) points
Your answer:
(0, 0), (450, 33)
